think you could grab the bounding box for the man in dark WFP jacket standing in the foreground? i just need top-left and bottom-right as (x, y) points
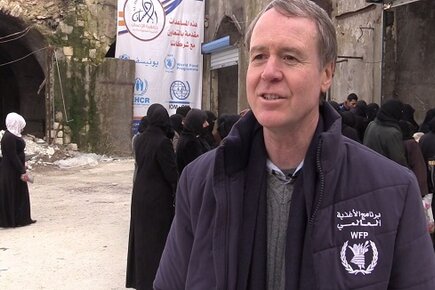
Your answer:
(154, 0), (435, 290)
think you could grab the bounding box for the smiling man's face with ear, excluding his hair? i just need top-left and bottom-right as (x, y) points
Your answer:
(246, 8), (333, 130)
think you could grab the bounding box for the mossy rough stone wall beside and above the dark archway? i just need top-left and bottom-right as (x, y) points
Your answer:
(0, 0), (117, 151)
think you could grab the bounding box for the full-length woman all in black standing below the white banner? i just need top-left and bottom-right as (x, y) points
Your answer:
(126, 104), (178, 290)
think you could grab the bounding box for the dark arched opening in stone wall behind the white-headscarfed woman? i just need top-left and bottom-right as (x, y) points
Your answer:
(0, 13), (48, 138)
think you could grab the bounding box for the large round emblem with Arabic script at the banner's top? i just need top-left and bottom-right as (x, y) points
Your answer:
(124, 0), (166, 41)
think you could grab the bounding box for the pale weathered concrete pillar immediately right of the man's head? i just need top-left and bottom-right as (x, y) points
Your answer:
(330, 0), (383, 103)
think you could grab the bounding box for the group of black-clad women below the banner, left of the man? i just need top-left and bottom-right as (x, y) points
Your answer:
(126, 104), (240, 289)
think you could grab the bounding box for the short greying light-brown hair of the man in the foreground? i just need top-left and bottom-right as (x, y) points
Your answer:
(245, 0), (337, 67)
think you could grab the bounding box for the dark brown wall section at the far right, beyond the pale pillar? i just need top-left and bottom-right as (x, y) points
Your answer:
(384, 1), (435, 123)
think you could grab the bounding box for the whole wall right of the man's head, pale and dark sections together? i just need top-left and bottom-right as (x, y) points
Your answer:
(331, 0), (435, 122)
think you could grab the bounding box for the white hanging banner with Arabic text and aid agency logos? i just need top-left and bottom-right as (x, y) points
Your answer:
(115, 0), (204, 131)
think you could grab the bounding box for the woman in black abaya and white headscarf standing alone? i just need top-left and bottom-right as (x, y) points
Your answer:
(0, 113), (35, 228)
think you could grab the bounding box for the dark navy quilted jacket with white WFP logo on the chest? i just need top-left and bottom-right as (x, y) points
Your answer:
(154, 105), (435, 290)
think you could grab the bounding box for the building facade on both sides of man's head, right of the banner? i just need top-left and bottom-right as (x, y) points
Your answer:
(203, 0), (435, 122)
